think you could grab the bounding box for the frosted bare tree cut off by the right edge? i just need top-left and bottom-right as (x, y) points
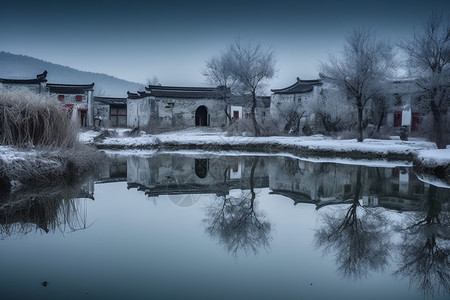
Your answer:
(400, 13), (450, 149)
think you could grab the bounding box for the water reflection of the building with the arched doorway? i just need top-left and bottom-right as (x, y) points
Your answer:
(127, 154), (269, 202)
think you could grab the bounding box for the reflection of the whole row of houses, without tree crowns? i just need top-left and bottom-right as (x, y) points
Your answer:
(99, 153), (448, 211)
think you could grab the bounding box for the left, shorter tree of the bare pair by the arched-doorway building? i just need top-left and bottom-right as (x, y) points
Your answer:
(203, 53), (236, 123)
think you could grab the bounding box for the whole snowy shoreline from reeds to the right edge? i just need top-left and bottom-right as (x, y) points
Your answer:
(80, 128), (450, 185)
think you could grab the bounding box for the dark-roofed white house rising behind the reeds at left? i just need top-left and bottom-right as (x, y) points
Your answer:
(0, 71), (94, 126)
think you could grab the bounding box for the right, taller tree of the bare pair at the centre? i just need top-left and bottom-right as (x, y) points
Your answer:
(225, 40), (276, 136)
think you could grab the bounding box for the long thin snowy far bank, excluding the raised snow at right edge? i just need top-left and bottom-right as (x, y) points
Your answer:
(80, 128), (440, 161)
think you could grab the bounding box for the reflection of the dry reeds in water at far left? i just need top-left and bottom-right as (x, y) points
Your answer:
(0, 180), (92, 239)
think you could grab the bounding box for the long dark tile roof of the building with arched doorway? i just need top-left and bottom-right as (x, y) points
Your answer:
(145, 85), (221, 99)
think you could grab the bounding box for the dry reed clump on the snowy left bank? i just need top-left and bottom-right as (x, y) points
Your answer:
(0, 88), (100, 190)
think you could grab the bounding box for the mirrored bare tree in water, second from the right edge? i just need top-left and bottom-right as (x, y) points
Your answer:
(315, 167), (390, 279)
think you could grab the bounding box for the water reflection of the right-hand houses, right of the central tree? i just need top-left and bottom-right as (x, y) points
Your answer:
(269, 157), (436, 210)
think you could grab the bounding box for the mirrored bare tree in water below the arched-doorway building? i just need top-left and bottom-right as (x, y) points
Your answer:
(203, 158), (271, 256)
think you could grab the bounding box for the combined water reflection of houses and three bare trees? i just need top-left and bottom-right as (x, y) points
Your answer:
(109, 153), (450, 297)
